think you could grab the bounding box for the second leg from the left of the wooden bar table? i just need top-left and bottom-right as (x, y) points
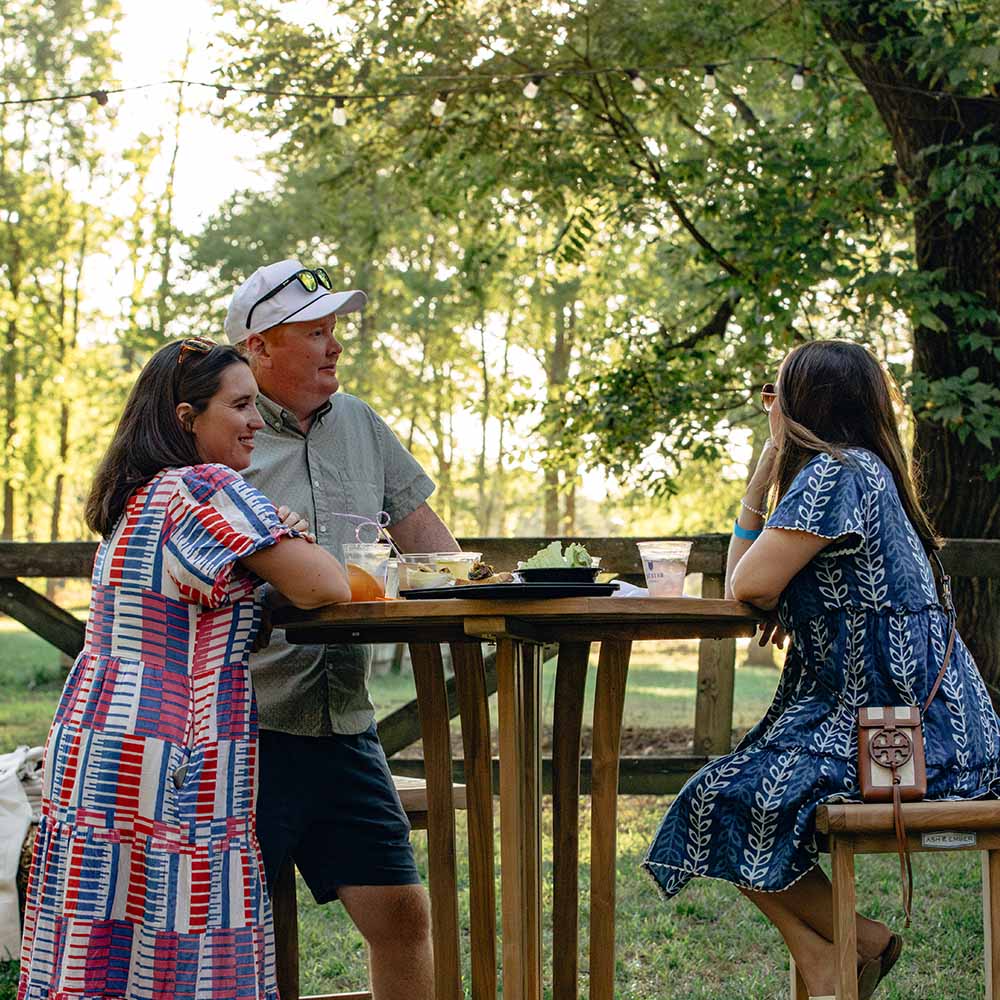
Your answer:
(451, 642), (497, 1000)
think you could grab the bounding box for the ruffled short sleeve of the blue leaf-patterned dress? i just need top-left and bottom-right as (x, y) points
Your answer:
(765, 453), (866, 555)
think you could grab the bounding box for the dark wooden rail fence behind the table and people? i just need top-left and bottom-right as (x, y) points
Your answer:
(0, 535), (1000, 794)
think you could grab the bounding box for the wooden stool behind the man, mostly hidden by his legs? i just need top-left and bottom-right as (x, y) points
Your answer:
(271, 775), (465, 1000)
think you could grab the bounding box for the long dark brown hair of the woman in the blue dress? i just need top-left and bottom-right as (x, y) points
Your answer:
(775, 340), (941, 552)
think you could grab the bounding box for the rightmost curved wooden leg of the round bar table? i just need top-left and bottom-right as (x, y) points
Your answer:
(590, 642), (632, 1000)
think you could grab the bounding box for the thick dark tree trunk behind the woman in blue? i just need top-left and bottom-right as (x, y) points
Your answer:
(821, 0), (1000, 704)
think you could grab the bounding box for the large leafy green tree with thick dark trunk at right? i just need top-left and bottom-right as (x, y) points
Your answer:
(209, 0), (1000, 677)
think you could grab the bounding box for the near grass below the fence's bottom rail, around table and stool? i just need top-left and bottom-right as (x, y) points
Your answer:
(299, 796), (983, 1000)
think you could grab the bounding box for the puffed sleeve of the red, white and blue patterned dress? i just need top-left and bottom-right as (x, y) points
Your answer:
(163, 465), (299, 608)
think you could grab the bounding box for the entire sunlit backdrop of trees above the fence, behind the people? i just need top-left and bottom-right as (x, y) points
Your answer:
(0, 0), (1000, 683)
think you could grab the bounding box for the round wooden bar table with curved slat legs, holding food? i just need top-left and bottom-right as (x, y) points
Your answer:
(275, 597), (760, 1000)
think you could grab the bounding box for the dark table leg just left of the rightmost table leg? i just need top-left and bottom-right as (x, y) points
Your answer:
(552, 642), (590, 1000)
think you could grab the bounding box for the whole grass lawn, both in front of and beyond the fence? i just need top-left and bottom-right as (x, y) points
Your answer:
(0, 619), (983, 1000)
